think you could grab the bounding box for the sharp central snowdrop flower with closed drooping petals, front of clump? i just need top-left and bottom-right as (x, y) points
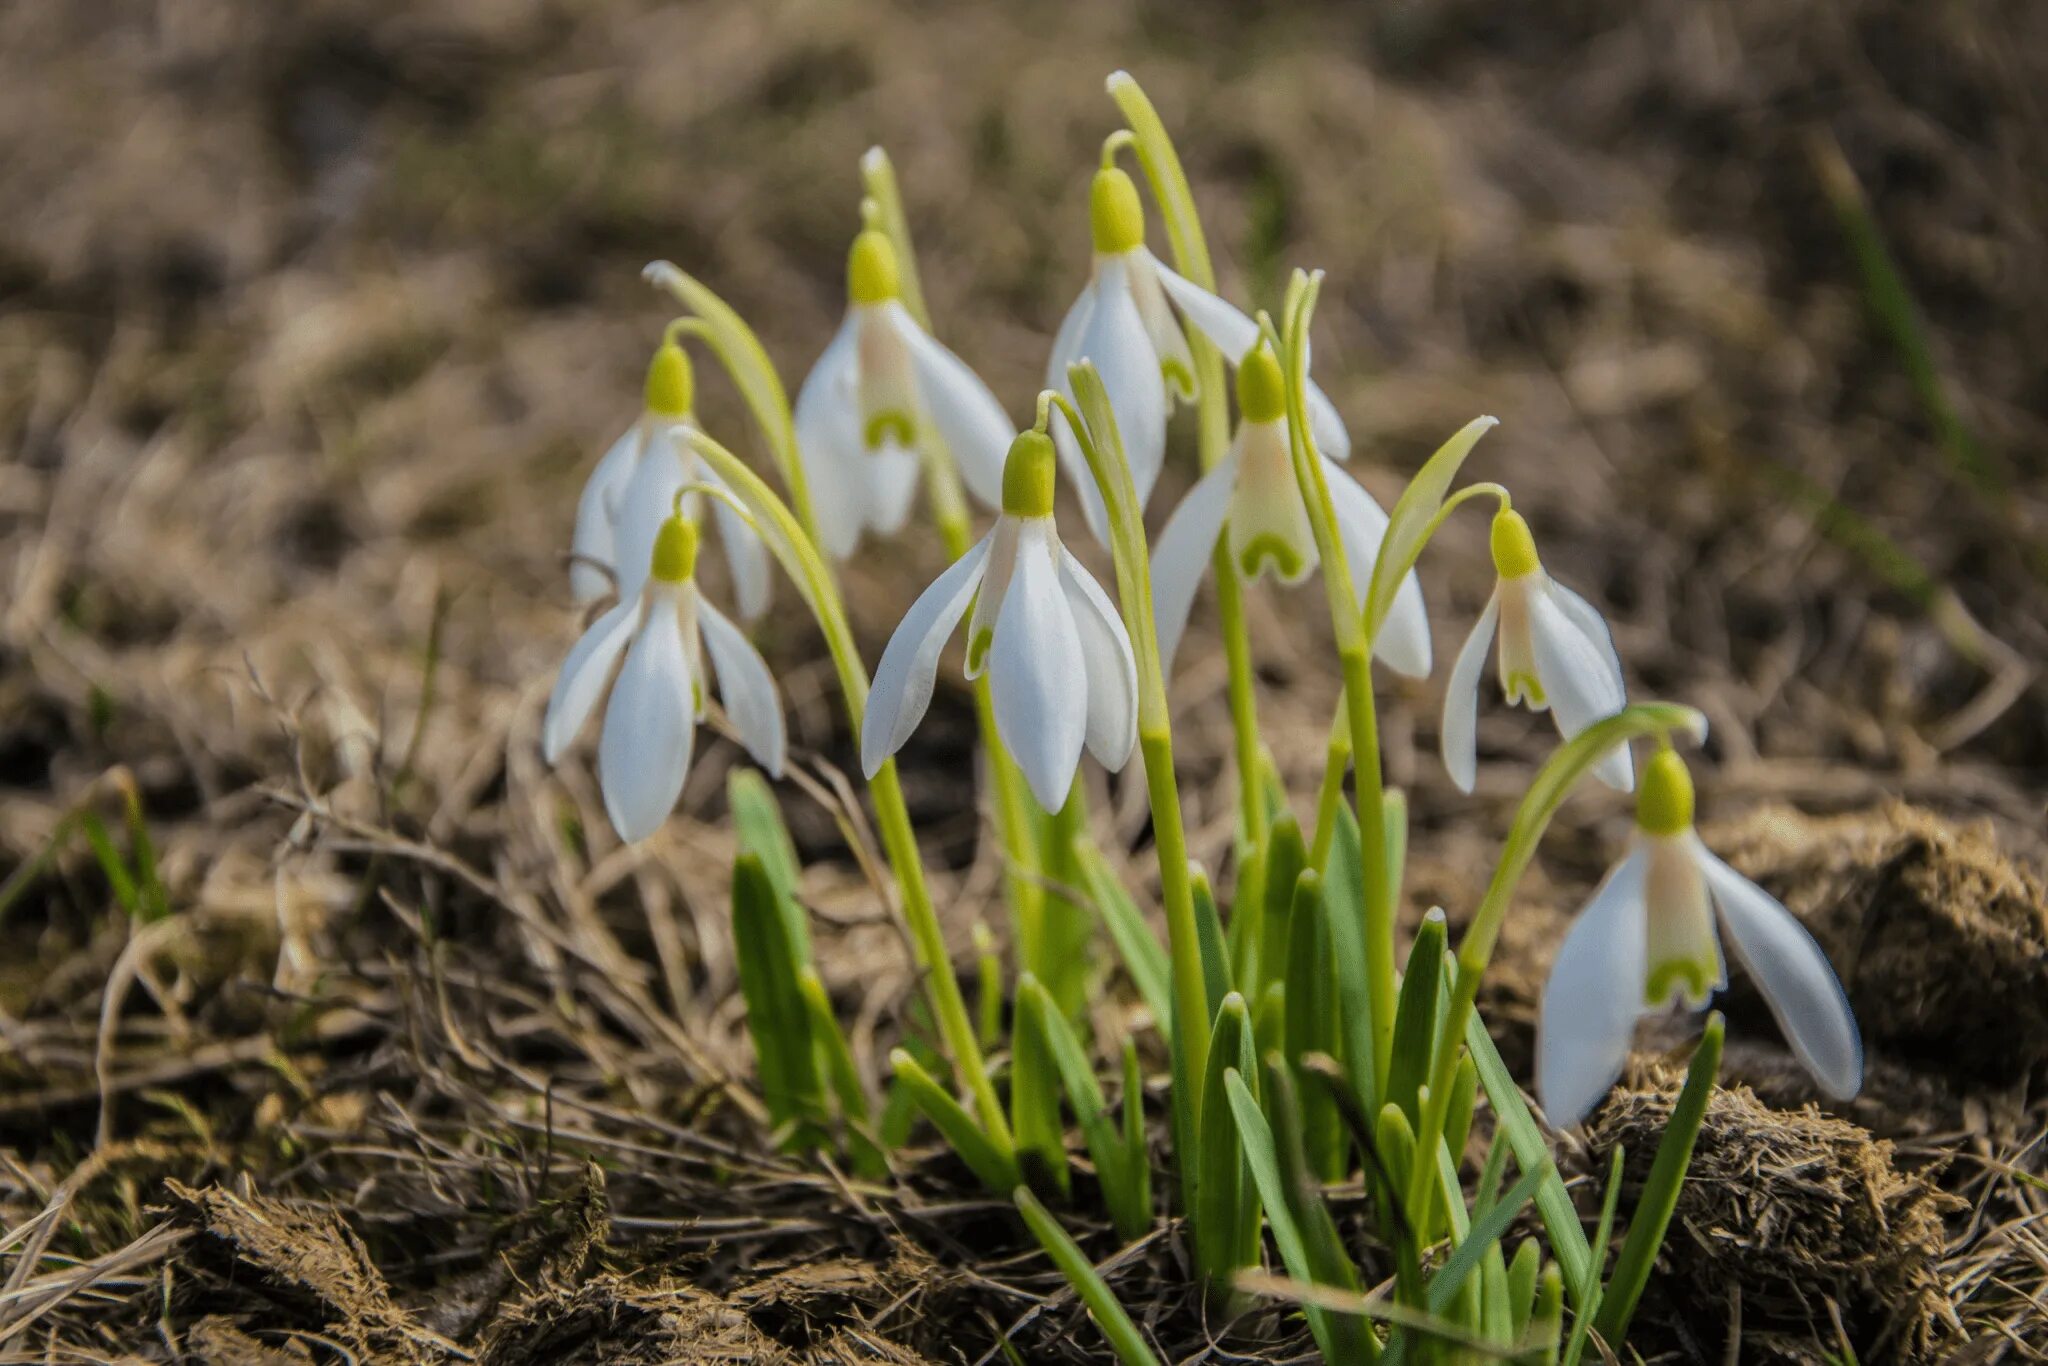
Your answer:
(860, 432), (1139, 811)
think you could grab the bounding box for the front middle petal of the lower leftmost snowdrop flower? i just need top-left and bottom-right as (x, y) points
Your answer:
(598, 590), (696, 844)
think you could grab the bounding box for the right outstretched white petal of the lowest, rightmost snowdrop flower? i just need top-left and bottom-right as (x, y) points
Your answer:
(1694, 836), (1864, 1100)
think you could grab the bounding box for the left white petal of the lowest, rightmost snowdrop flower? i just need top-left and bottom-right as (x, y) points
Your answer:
(1536, 846), (1649, 1128)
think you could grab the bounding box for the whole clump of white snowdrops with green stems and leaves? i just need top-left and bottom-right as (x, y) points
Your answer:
(543, 74), (1862, 1356)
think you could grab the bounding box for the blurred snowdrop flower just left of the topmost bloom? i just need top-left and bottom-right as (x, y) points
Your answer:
(797, 227), (1016, 559)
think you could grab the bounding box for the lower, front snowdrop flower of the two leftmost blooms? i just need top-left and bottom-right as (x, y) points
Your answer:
(541, 516), (784, 844)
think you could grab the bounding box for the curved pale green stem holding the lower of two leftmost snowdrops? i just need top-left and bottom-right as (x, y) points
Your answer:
(690, 432), (1014, 1153)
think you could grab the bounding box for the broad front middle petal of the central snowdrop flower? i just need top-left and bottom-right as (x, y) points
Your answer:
(989, 520), (1089, 811)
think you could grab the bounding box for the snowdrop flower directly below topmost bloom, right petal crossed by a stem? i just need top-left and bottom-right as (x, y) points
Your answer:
(1151, 340), (1430, 678)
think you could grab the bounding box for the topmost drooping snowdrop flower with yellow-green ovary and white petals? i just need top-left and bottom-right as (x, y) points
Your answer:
(1044, 166), (1352, 541)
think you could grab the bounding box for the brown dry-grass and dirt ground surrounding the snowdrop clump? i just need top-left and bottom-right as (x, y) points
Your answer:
(0, 0), (2048, 1362)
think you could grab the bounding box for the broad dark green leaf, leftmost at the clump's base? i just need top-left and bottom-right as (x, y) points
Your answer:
(733, 854), (825, 1147)
